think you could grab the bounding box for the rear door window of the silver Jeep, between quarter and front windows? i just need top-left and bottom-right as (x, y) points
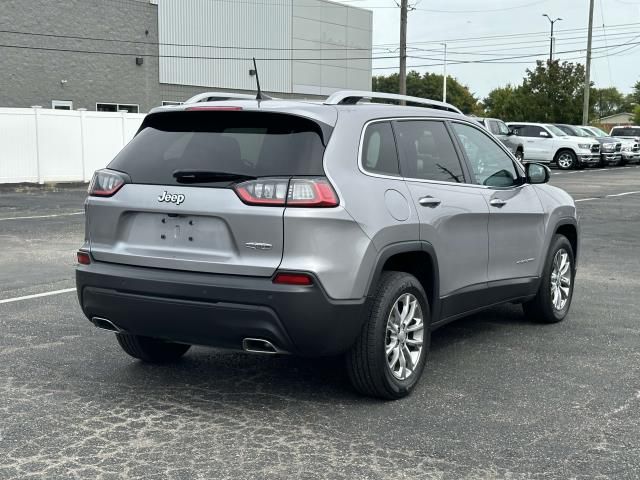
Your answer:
(395, 120), (464, 183)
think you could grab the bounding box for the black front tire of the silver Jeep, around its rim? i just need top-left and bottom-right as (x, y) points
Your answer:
(522, 235), (576, 323)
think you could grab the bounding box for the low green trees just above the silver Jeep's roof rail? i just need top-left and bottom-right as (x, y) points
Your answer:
(373, 70), (482, 113)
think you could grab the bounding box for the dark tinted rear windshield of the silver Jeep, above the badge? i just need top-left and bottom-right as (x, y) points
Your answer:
(109, 111), (330, 185)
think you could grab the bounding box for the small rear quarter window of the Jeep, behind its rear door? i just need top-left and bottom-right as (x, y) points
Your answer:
(362, 122), (400, 176)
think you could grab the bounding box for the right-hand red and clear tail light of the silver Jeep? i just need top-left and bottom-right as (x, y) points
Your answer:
(234, 177), (340, 208)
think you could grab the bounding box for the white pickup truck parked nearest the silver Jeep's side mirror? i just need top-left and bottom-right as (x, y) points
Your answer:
(507, 122), (600, 170)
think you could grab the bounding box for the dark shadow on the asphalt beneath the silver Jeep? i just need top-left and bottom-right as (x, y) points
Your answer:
(103, 306), (533, 404)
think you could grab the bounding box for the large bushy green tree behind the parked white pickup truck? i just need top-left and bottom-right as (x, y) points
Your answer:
(484, 61), (595, 124)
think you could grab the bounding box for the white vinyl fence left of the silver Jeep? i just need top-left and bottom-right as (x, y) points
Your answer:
(0, 108), (145, 183)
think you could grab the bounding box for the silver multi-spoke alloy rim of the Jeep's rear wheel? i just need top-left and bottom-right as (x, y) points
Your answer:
(385, 293), (424, 380)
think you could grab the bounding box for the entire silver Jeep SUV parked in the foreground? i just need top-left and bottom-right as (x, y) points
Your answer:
(76, 91), (579, 398)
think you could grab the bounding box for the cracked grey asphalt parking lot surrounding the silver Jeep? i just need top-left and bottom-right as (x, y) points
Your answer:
(0, 166), (640, 480)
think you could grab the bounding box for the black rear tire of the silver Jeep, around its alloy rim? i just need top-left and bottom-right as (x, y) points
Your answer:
(346, 272), (431, 400)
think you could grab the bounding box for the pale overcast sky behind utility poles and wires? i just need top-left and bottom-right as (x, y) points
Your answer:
(343, 0), (640, 98)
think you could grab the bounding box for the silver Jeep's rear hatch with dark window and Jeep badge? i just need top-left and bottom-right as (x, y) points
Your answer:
(87, 109), (330, 276)
